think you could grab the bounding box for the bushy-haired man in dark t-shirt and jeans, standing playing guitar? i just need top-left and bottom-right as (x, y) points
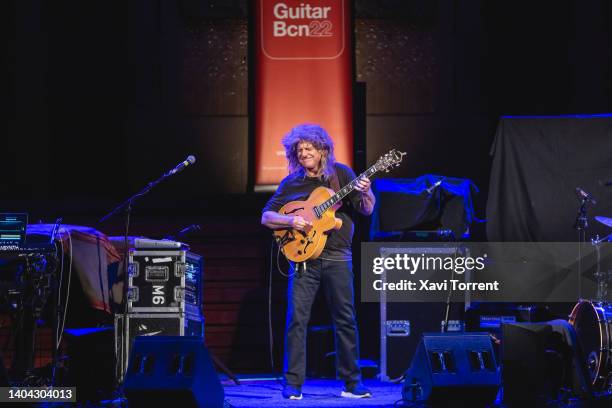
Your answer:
(261, 124), (375, 399)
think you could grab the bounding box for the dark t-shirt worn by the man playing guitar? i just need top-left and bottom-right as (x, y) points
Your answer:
(262, 163), (361, 261)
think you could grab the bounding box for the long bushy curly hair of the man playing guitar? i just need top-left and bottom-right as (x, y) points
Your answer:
(282, 123), (336, 178)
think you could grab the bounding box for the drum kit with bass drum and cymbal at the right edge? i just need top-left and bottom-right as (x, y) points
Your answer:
(569, 216), (612, 392)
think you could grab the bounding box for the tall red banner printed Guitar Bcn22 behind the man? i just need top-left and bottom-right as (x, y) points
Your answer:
(254, 0), (353, 186)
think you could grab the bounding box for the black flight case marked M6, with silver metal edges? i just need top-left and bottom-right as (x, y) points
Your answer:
(128, 249), (203, 315)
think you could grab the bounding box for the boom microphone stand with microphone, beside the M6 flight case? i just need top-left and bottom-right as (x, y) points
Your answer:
(98, 172), (174, 386)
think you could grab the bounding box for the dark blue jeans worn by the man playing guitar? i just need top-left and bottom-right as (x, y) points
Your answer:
(284, 259), (361, 386)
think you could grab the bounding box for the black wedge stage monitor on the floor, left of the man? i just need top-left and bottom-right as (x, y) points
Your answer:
(124, 336), (225, 408)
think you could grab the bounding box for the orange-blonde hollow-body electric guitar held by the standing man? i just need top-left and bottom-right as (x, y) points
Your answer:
(274, 149), (406, 262)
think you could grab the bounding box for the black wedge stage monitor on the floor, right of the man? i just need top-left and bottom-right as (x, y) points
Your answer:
(402, 333), (500, 407)
